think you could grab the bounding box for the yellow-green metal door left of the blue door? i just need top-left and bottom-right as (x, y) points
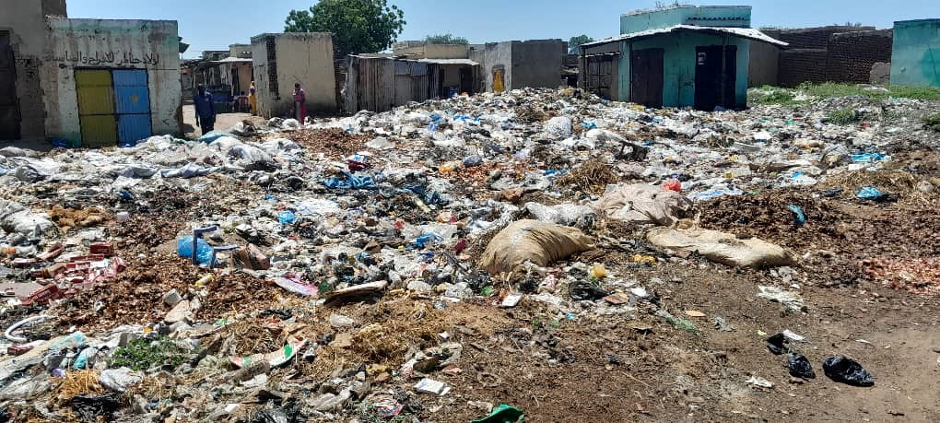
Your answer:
(75, 70), (118, 147)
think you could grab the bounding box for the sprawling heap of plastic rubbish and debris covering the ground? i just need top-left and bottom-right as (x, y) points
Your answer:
(0, 89), (939, 422)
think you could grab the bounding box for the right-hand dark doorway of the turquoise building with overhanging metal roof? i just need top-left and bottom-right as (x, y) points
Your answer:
(694, 46), (737, 110)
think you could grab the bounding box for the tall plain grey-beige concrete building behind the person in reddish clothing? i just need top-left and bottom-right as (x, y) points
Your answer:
(252, 32), (337, 118)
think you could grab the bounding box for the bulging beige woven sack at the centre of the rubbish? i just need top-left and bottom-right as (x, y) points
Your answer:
(480, 219), (594, 275)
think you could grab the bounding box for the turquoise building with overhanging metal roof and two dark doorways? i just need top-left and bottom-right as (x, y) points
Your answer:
(579, 6), (787, 110)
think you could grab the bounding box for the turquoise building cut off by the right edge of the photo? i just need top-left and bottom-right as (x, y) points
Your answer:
(891, 19), (941, 87)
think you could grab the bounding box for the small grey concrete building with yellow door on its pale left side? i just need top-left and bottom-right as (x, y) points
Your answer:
(482, 40), (568, 93)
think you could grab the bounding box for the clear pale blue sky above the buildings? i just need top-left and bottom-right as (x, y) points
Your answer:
(68, 0), (941, 57)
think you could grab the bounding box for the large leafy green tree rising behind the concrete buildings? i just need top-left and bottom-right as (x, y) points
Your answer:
(284, 0), (405, 56)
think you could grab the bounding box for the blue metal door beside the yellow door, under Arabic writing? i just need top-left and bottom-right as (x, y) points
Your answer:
(112, 70), (153, 146)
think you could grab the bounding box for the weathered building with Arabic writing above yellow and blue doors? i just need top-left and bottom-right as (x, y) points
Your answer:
(0, 0), (182, 147)
